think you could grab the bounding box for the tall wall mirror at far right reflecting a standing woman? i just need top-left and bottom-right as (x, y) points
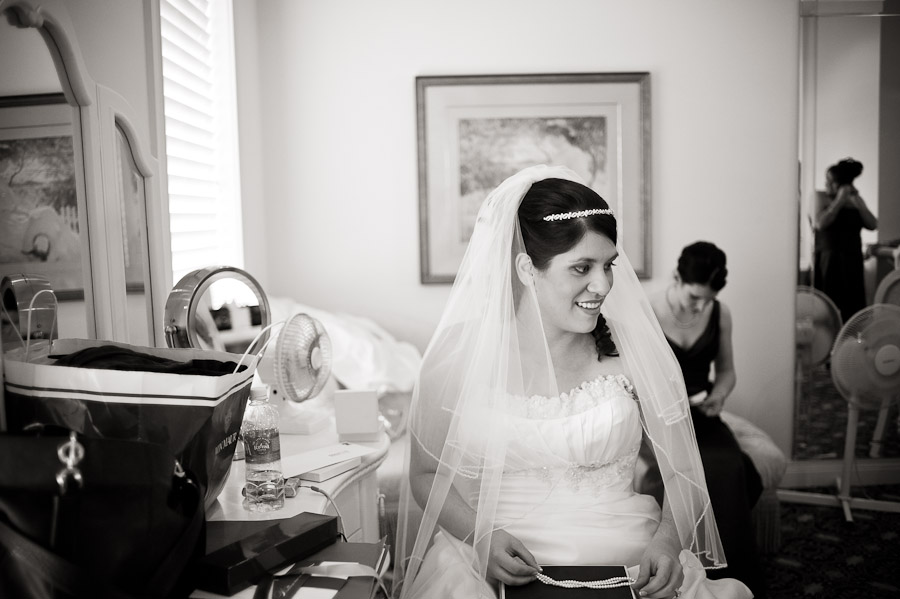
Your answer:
(792, 0), (900, 468)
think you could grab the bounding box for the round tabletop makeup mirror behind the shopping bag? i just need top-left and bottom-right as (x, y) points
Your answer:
(165, 266), (271, 353)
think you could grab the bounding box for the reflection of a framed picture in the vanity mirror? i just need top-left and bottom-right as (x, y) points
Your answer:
(0, 93), (84, 300)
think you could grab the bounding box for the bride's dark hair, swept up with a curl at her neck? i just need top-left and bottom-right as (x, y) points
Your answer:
(517, 179), (618, 360)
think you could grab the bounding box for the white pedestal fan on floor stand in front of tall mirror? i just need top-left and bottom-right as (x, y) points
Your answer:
(779, 304), (900, 522)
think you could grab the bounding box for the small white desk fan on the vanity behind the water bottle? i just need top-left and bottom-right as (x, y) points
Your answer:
(257, 313), (331, 434)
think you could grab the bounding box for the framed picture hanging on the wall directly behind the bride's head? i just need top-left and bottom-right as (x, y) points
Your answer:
(416, 72), (650, 284)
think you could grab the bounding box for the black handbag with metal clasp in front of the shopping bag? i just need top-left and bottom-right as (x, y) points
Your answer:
(0, 432), (206, 599)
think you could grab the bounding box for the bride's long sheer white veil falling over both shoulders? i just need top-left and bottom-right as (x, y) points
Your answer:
(394, 166), (724, 597)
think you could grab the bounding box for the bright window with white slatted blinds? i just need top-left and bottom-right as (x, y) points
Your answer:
(160, 0), (243, 282)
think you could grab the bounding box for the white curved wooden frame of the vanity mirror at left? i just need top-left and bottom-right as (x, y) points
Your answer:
(0, 0), (172, 346)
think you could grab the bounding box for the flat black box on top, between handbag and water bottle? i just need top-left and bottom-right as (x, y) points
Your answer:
(194, 512), (338, 595)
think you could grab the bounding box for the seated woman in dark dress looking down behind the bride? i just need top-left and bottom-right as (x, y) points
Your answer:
(650, 241), (766, 599)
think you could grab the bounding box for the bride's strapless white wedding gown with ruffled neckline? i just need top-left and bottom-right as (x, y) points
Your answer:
(406, 375), (752, 599)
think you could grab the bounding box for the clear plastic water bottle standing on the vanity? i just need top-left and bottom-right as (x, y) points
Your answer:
(241, 387), (284, 512)
